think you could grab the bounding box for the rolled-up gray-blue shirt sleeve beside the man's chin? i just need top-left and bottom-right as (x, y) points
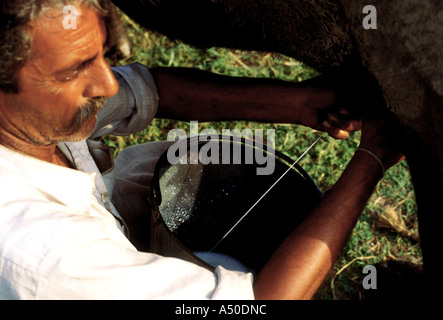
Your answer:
(90, 63), (159, 139)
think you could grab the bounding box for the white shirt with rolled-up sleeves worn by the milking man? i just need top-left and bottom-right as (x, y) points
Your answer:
(0, 65), (254, 299)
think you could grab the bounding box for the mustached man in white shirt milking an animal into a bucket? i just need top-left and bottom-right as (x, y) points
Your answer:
(0, 0), (401, 299)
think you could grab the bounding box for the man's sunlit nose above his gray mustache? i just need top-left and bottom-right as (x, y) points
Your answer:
(84, 57), (118, 98)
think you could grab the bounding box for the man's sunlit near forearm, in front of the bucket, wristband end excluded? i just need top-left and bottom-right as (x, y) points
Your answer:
(255, 152), (382, 299)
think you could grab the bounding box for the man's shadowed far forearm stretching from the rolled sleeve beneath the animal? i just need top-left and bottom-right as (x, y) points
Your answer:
(151, 68), (334, 124)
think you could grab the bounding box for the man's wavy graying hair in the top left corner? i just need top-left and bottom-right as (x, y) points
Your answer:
(0, 0), (121, 93)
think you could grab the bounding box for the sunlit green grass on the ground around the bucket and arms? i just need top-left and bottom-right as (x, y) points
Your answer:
(104, 11), (422, 299)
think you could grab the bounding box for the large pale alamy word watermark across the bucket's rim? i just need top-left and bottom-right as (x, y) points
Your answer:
(167, 121), (275, 175)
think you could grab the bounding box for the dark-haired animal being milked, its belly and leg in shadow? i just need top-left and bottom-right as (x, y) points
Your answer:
(114, 0), (443, 294)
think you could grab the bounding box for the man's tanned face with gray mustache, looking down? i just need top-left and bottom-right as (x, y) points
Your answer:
(0, 7), (118, 145)
